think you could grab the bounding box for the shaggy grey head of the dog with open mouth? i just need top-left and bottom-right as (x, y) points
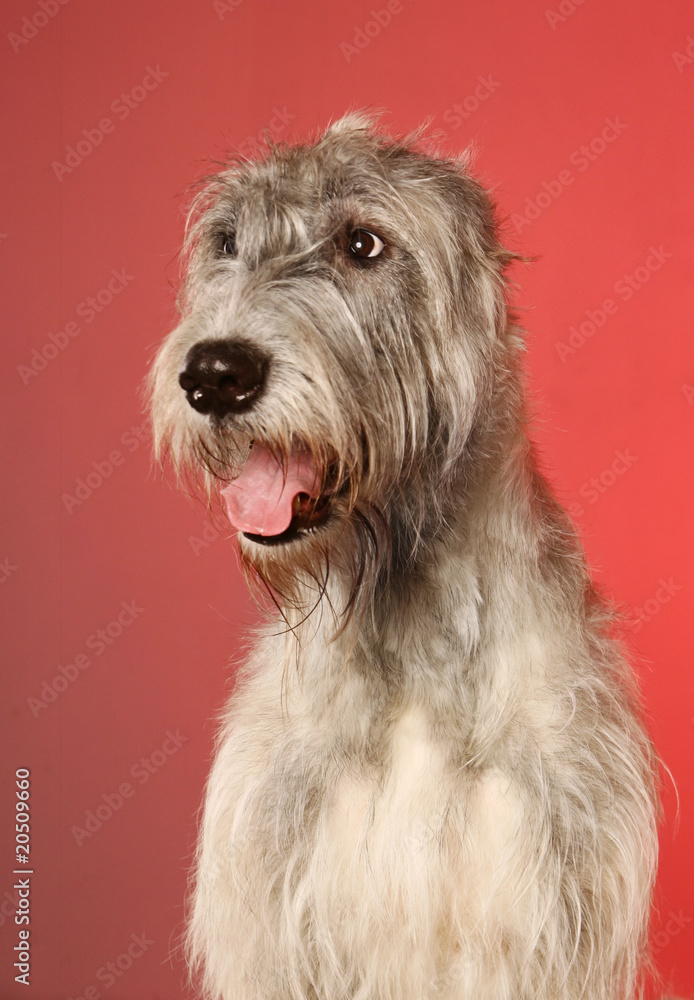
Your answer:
(152, 116), (508, 604)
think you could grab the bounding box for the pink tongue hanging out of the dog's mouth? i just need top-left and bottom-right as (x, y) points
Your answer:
(222, 445), (318, 535)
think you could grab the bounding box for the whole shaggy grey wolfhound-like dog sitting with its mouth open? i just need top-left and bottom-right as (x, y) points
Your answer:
(152, 115), (656, 1000)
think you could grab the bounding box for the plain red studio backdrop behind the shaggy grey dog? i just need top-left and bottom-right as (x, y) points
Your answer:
(0, 0), (694, 1000)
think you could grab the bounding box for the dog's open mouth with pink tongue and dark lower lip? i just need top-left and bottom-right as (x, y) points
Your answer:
(221, 443), (337, 545)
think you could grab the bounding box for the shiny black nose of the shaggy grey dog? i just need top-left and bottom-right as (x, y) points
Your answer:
(178, 340), (267, 417)
